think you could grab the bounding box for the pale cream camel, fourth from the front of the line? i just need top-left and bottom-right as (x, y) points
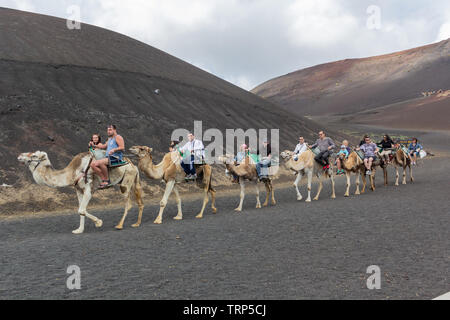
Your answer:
(281, 150), (336, 202)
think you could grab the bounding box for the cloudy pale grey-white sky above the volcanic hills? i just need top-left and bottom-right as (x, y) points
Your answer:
(0, 0), (450, 90)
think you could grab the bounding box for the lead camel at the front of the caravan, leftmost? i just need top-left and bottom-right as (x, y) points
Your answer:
(18, 151), (144, 234)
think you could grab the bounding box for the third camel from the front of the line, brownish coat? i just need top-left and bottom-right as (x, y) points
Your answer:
(218, 155), (277, 212)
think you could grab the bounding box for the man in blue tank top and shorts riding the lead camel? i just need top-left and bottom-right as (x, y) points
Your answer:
(91, 124), (125, 189)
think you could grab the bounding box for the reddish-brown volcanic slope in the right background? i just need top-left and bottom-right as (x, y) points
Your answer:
(252, 40), (450, 116)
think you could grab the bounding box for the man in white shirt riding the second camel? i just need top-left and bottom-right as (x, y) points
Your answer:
(180, 133), (205, 180)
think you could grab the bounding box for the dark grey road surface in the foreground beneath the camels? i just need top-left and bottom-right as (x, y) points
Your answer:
(0, 158), (450, 299)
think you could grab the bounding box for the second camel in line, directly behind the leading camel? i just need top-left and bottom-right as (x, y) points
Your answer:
(129, 146), (217, 224)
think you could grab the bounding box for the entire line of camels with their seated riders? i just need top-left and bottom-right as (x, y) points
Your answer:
(18, 125), (425, 234)
